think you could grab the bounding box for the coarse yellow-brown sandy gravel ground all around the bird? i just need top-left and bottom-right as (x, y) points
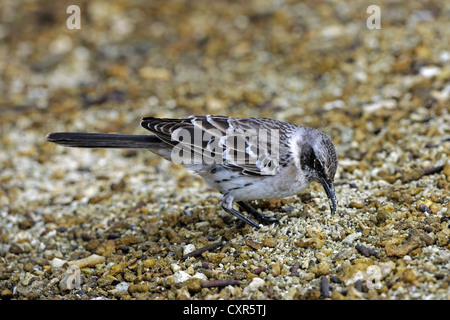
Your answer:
(0, 0), (450, 300)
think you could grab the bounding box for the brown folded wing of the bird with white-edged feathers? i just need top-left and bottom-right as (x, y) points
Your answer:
(141, 115), (295, 175)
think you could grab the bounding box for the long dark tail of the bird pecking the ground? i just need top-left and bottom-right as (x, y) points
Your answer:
(47, 132), (162, 149)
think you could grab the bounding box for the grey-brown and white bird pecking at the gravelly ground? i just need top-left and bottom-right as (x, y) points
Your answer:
(47, 115), (338, 229)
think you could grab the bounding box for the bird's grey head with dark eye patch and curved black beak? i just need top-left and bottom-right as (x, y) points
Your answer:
(300, 129), (338, 213)
